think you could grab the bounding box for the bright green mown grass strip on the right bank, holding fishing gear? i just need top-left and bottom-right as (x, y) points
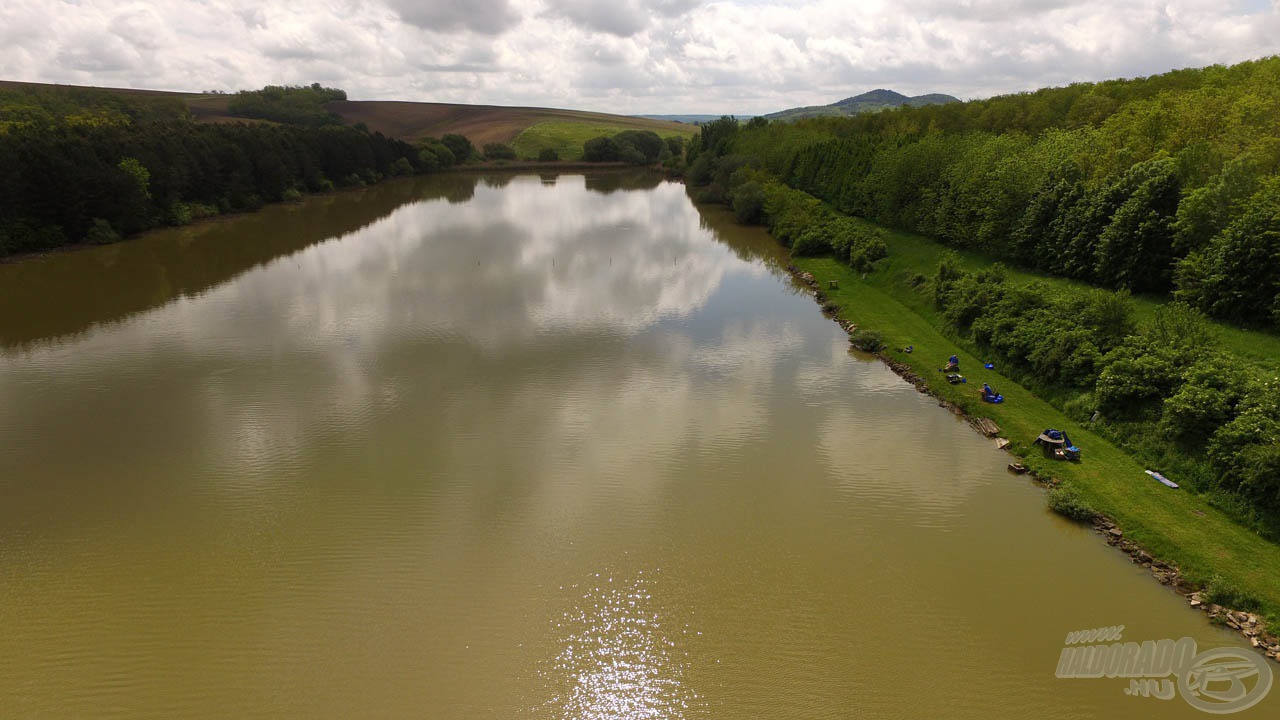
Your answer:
(795, 249), (1280, 621)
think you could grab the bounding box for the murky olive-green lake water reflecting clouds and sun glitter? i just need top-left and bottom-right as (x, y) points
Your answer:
(0, 170), (1259, 720)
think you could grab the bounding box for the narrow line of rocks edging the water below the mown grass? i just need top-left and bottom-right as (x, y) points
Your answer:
(786, 264), (1280, 662)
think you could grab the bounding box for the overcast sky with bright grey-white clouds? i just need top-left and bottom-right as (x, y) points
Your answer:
(0, 0), (1280, 114)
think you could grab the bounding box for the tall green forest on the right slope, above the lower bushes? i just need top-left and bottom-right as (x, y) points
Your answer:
(727, 58), (1280, 327)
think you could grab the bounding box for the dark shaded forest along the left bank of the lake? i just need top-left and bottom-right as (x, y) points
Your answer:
(0, 83), (440, 256)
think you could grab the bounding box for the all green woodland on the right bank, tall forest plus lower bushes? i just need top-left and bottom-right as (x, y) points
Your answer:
(687, 58), (1280, 527)
